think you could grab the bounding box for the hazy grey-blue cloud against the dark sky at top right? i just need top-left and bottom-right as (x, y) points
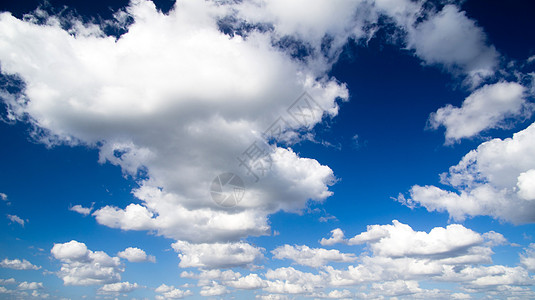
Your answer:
(407, 5), (499, 84)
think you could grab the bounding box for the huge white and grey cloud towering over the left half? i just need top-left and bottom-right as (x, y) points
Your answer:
(0, 1), (348, 247)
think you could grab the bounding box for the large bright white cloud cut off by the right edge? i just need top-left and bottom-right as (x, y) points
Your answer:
(404, 123), (535, 223)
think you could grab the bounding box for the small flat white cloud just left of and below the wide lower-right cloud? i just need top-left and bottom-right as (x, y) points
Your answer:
(271, 245), (356, 267)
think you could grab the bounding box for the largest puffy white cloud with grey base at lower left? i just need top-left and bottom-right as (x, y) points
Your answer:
(51, 240), (124, 285)
